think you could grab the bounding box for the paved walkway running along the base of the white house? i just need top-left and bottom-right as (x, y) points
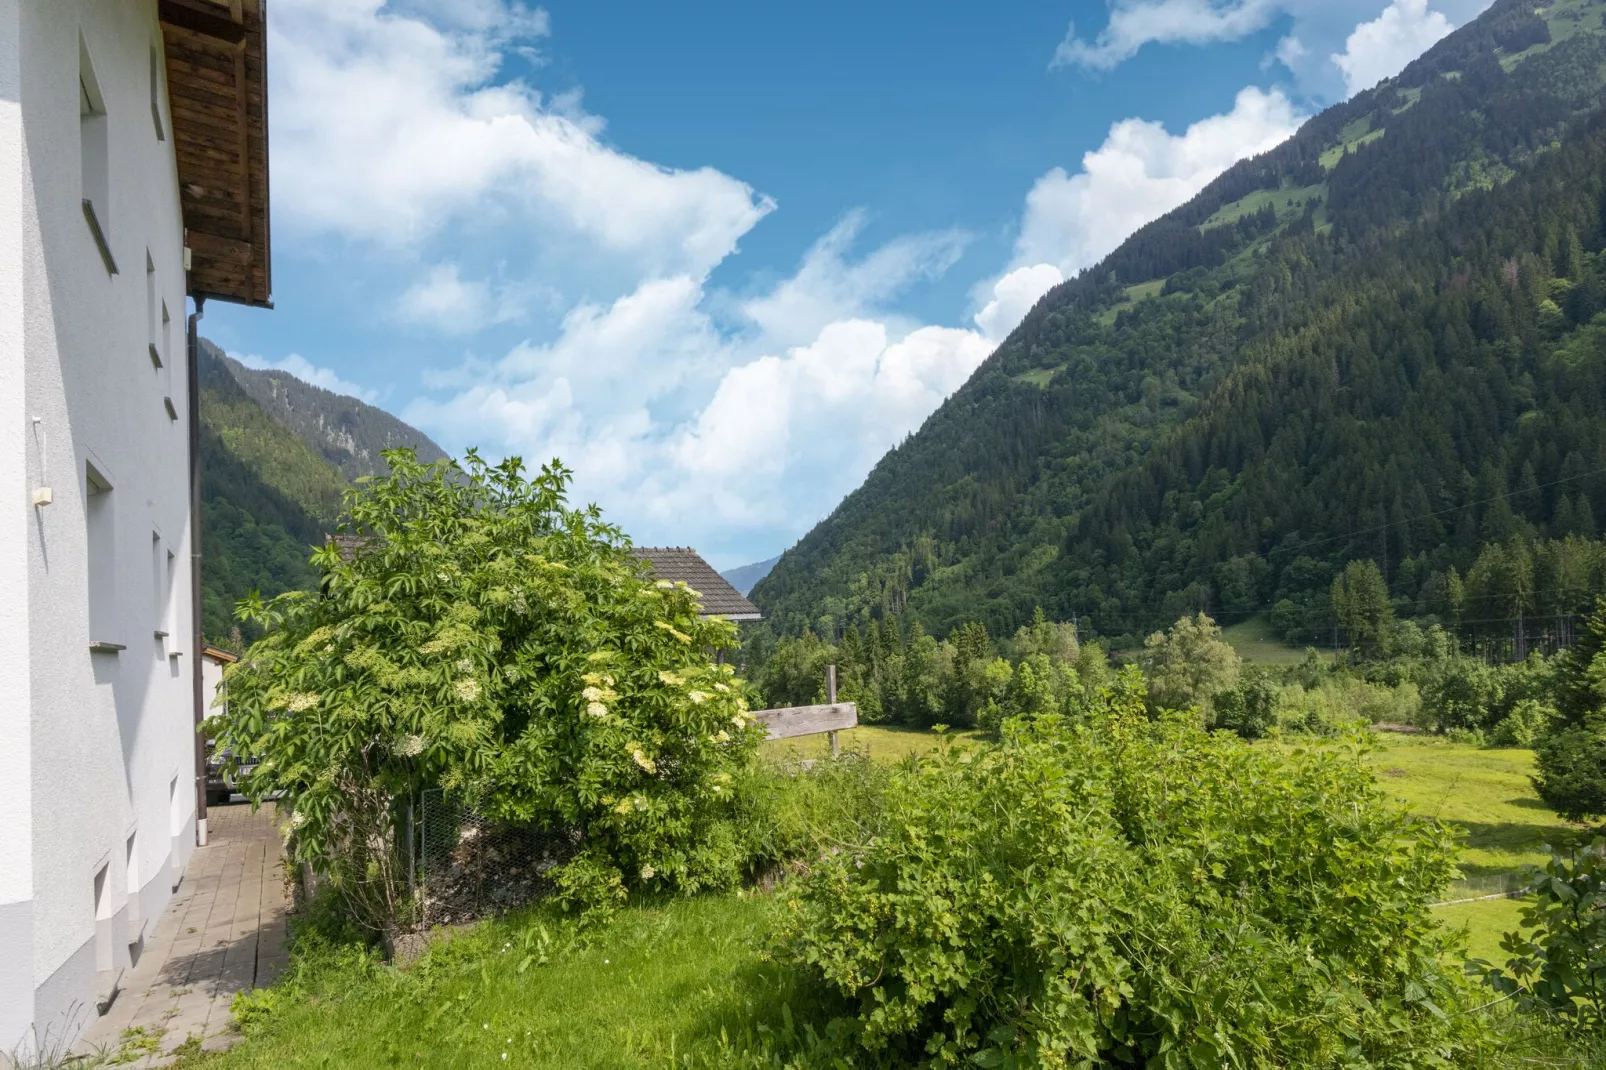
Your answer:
(79, 803), (287, 1067)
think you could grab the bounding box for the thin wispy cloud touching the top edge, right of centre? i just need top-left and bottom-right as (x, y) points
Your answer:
(1049, 0), (1285, 71)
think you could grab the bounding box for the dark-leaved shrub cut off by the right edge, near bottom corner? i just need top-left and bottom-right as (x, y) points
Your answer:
(1469, 837), (1606, 1036)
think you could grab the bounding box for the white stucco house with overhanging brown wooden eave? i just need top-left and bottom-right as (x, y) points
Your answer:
(0, 0), (268, 1062)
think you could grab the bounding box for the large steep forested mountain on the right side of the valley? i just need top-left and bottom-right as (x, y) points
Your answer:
(753, 0), (1606, 638)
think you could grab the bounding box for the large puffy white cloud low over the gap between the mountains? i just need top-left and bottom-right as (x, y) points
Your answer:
(405, 214), (991, 546)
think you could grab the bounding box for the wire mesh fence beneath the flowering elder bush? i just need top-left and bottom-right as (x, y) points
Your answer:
(414, 789), (575, 927)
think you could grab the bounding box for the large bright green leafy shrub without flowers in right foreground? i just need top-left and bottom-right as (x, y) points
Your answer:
(779, 673), (1482, 1067)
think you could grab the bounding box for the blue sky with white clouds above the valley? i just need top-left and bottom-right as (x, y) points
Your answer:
(202, 0), (1487, 567)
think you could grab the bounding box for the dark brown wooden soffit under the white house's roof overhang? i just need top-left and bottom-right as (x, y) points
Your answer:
(157, 0), (273, 308)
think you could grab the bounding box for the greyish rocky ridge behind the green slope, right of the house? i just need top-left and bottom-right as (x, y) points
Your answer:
(206, 342), (446, 479)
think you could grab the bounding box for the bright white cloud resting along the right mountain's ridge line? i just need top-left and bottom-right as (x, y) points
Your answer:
(1015, 85), (1304, 276)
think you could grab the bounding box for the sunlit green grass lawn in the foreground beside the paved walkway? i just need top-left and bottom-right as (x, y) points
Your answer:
(183, 895), (787, 1070)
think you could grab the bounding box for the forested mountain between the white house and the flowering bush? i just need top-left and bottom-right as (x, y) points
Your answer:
(199, 339), (443, 644)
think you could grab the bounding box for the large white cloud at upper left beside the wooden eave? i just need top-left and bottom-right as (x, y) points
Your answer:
(270, 0), (774, 273)
